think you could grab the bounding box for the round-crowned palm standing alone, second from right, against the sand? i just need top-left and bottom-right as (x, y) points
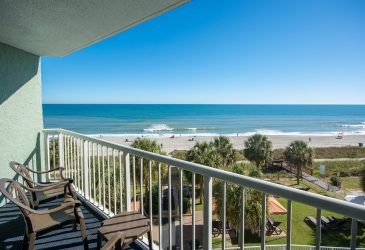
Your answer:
(243, 134), (273, 168)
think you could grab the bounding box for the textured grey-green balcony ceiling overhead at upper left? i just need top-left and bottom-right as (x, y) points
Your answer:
(0, 0), (188, 56)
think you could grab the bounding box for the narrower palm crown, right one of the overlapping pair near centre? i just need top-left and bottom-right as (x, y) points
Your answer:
(212, 136), (236, 167)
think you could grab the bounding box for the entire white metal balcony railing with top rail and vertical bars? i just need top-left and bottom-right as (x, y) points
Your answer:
(43, 129), (365, 249)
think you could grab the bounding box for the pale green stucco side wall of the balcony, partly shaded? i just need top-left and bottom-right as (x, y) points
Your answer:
(0, 43), (43, 205)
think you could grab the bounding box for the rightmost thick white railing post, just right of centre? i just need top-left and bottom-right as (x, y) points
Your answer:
(200, 176), (212, 250)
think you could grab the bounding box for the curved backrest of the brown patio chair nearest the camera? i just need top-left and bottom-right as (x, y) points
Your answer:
(0, 178), (30, 217)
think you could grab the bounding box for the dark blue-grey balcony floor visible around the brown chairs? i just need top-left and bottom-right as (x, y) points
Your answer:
(0, 200), (141, 250)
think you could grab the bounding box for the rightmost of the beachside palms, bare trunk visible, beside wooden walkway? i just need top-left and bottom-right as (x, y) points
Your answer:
(284, 141), (314, 184)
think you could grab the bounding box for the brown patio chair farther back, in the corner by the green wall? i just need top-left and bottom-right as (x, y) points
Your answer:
(10, 161), (77, 209)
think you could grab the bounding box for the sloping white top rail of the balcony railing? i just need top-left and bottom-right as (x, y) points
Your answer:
(43, 129), (365, 221)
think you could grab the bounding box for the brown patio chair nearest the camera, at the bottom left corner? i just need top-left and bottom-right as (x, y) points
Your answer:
(0, 179), (88, 250)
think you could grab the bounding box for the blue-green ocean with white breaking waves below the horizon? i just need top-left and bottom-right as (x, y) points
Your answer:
(43, 104), (365, 137)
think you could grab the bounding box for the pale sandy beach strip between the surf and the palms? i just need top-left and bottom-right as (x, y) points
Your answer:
(102, 135), (365, 153)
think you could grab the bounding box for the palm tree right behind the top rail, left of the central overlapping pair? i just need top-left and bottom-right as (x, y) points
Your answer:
(184, 142), (222, 203)
